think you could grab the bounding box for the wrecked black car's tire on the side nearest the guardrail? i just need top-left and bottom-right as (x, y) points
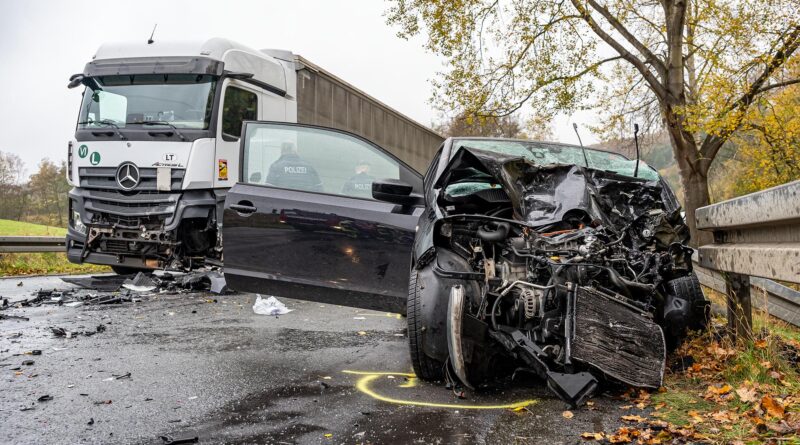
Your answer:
(663, 272), (708, 350)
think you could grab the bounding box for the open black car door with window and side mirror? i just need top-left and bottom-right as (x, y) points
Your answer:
(222, 122), (423, 313)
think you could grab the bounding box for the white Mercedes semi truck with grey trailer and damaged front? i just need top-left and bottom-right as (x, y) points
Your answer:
(66, 38), (443, 273)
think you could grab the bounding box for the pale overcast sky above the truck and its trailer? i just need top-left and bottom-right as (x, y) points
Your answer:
(0, 0), (594, 174)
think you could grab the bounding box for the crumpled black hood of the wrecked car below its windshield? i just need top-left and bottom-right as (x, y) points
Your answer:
(435, 147), (683, 236)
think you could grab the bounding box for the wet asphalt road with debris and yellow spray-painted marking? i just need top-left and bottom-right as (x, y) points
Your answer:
(0, 278), (630, 445)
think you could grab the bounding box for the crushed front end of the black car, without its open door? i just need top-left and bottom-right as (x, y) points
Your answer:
(408, 141), (708, 405)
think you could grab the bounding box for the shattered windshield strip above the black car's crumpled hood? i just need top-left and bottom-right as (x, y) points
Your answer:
(452, 139), (659, 181)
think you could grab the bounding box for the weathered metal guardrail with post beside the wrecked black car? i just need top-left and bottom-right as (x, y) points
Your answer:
(696, 181), (800, 335)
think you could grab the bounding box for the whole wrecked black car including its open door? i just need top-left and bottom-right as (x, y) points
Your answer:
(223, 122), (708, 405)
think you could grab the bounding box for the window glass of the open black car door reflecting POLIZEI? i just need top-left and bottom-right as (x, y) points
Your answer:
(242, 123), (406, 199)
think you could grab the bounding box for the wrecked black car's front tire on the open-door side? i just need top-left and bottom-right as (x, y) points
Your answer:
(406, 270), (444, 381)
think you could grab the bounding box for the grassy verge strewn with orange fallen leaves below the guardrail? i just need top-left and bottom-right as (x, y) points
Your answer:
(580, 314), (800, 445)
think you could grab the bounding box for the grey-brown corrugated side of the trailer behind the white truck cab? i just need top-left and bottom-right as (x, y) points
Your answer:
(295, 56), (444, 172)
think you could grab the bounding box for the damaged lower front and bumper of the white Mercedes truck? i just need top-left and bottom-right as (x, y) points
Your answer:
(66, 188), (224, 269)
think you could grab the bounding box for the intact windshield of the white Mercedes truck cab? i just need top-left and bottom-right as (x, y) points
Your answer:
(78, 74), (217, 129)
